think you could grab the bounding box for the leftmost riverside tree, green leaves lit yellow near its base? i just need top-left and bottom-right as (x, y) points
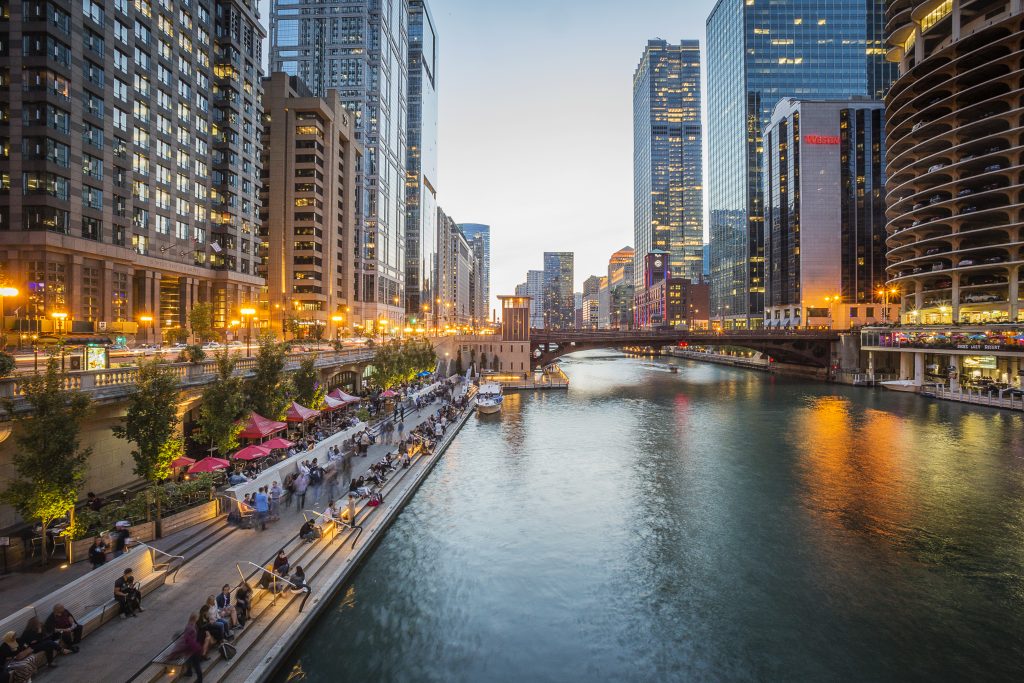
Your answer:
(0, 355), (92, 563)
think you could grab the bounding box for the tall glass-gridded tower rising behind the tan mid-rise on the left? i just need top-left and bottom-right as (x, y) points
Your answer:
(270, 0), (409, 327)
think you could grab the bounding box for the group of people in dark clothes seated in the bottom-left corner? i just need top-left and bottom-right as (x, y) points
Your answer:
(0, 603), (82, 683)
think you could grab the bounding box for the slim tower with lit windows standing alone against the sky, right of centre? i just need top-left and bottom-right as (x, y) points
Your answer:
(633, 40), (703, 287)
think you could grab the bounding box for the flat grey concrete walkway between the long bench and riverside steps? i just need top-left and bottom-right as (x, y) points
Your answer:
(4, 393), (452, 682)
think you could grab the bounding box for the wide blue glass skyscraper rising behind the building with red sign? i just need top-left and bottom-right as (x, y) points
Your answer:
(708, 0), (895, 328)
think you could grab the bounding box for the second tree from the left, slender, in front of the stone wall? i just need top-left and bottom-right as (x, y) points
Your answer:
(114, 358), (183, 522)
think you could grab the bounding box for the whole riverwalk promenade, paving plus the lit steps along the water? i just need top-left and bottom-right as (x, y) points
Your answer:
(0, 389), (472, 683)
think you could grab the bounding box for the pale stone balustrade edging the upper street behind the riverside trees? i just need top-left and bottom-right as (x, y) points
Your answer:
(0, 349), (375, 399)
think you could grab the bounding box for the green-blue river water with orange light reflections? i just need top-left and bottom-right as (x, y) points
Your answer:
(280, 352), (1024, 682)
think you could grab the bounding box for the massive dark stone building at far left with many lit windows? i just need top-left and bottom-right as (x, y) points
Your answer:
(0, 0), (263, 341)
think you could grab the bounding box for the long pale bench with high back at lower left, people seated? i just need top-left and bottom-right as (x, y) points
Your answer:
(0, 545), (179, 647)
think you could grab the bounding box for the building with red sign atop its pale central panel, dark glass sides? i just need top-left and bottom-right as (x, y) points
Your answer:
(762, 98), (886, 329)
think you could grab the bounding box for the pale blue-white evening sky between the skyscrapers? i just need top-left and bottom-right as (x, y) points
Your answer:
(428, 0), (715, 307)
